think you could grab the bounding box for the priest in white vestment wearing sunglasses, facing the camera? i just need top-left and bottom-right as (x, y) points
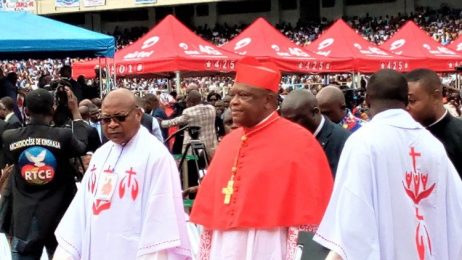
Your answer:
(55, 89), (191, 260)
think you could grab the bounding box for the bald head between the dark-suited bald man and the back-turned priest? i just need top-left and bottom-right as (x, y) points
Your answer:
(316, 86), (346, 124)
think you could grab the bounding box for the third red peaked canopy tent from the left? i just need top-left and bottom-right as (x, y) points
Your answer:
(306, 19), (415, 73)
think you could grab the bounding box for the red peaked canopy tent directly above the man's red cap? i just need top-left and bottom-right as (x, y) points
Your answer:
(222, 18), (352, 73)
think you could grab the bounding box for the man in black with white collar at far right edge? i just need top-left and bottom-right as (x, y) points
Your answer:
(406, 69), (462, 178)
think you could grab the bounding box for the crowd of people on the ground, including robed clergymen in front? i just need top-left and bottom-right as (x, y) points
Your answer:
(0, 50), (462, 260)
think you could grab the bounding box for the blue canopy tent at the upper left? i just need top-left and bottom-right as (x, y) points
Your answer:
(0, 11), (115, 59)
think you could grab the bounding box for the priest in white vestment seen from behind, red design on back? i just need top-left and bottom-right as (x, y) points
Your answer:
(314, 70), (462, 260)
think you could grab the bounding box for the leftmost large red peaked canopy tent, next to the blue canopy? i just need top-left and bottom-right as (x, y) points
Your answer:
(73, 15), (241, 77)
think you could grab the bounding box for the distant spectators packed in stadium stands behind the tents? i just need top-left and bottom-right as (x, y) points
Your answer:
(0, 6), (462, 97)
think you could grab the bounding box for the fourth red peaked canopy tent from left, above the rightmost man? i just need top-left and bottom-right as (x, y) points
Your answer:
(381, 21), (462, 72)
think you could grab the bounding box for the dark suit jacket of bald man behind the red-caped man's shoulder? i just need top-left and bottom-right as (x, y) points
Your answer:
(316, 117), (351, 177)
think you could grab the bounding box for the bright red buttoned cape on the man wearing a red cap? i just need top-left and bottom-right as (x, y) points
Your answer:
(191, 113), (333, 230)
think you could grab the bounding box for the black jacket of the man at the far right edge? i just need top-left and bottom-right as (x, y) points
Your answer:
(427, 113), (462, 178)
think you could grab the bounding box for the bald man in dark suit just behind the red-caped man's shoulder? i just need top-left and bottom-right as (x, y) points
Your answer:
(281, 90), (350, 176)
